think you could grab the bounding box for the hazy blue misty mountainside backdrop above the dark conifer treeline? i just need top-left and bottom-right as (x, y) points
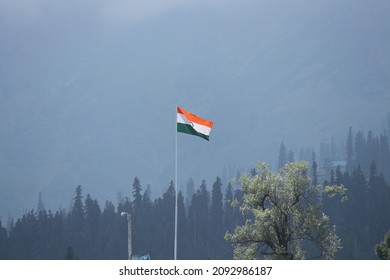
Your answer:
(0, 0), (390, 221)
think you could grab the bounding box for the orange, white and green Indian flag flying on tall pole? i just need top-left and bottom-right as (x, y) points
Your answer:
(177, 107), (213, 141)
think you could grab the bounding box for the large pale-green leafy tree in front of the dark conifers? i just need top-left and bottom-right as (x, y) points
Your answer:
(225, 162), (345, 259)
